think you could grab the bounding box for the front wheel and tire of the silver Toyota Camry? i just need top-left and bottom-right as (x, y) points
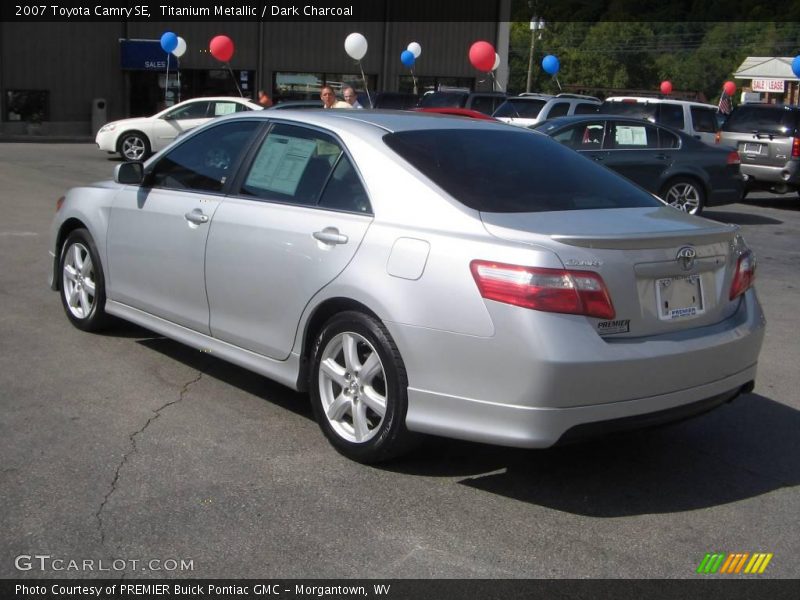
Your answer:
(58, 229), (110, 331)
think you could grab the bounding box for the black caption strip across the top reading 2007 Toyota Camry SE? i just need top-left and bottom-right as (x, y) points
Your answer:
(0, 0), (800, 23)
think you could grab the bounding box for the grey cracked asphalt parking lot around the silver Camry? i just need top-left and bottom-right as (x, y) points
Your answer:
(0, 144), (800, 578)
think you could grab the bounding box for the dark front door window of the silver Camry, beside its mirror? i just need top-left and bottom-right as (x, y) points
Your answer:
(149, 121), (259, 192)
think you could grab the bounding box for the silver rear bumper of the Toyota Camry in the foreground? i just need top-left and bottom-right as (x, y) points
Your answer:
(387, 290), (765, 447)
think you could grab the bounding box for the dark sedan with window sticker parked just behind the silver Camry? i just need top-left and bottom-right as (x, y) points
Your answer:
(531, 115), (744, 214)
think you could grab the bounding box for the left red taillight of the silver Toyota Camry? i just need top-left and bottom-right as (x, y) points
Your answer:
(470, 260), (615, 319)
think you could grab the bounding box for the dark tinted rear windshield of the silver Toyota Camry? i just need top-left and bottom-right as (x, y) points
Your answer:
(383, 127), (661, 213)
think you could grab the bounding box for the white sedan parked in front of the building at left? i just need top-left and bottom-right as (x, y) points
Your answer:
(95, 96), (262, 160)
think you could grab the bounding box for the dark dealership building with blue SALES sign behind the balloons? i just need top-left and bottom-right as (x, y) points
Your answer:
(0, 5), (511, 136)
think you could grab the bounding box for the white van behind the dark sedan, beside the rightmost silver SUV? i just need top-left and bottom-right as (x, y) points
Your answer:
(600, 96), (719, 146)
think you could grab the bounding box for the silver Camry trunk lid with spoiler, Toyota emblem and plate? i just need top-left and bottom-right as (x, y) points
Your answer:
(481, 207), (738, 337)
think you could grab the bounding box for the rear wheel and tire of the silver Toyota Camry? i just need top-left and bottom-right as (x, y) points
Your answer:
(310, 311), (417, 463)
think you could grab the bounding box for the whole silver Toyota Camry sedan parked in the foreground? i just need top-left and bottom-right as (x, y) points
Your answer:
(51, 110), (764, 462)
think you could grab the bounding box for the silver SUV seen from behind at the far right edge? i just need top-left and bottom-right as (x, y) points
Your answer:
(720, 104), (800, 194)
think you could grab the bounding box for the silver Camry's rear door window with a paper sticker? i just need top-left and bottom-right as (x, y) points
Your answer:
(241, 124), (342, 206)
